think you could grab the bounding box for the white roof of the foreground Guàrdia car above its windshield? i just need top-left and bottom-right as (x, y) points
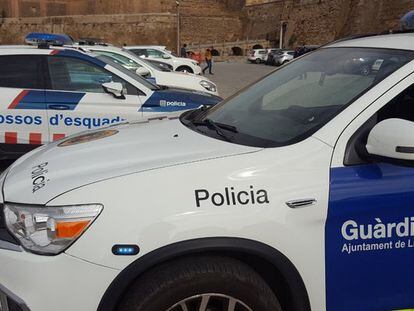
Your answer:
(323, 33), (414, 50)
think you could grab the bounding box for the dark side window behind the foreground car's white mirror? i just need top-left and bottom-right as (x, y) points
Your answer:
(344, 84), (414, 165)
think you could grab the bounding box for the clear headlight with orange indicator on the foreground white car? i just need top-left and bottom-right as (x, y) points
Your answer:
(4, 203), (103, 255)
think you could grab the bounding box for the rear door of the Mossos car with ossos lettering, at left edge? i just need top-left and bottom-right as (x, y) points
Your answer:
(0, 55), (48, 152)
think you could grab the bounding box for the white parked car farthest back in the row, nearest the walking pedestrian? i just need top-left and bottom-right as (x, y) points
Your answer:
(124, 45), (201, 75)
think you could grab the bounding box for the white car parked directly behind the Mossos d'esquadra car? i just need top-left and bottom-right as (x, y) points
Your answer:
(78, 45), (219, 96)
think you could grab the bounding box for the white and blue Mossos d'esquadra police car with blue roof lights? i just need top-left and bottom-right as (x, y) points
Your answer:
(0, 34), (221, 159)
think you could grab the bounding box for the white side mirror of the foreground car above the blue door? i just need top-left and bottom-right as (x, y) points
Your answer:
(366, 119), (414, 163)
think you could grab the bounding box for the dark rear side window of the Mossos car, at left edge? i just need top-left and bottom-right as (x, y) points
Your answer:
(0, 55), (44, 89)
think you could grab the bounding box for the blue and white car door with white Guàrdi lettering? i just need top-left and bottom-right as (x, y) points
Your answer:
(325, 75), (414, 311)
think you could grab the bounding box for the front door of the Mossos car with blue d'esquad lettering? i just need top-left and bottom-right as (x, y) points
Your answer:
(45, 55), (142, 141)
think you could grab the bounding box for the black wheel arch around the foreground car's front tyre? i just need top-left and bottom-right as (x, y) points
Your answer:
(98, 237), (310, 311)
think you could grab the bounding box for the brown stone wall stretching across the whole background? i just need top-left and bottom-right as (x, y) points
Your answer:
(0, 0), (414, 49)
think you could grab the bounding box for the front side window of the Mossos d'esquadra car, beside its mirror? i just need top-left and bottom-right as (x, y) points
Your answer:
(48, 56), (137, 95)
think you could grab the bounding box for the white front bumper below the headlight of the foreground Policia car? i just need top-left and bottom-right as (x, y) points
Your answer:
(0, 249), (119, 311)
